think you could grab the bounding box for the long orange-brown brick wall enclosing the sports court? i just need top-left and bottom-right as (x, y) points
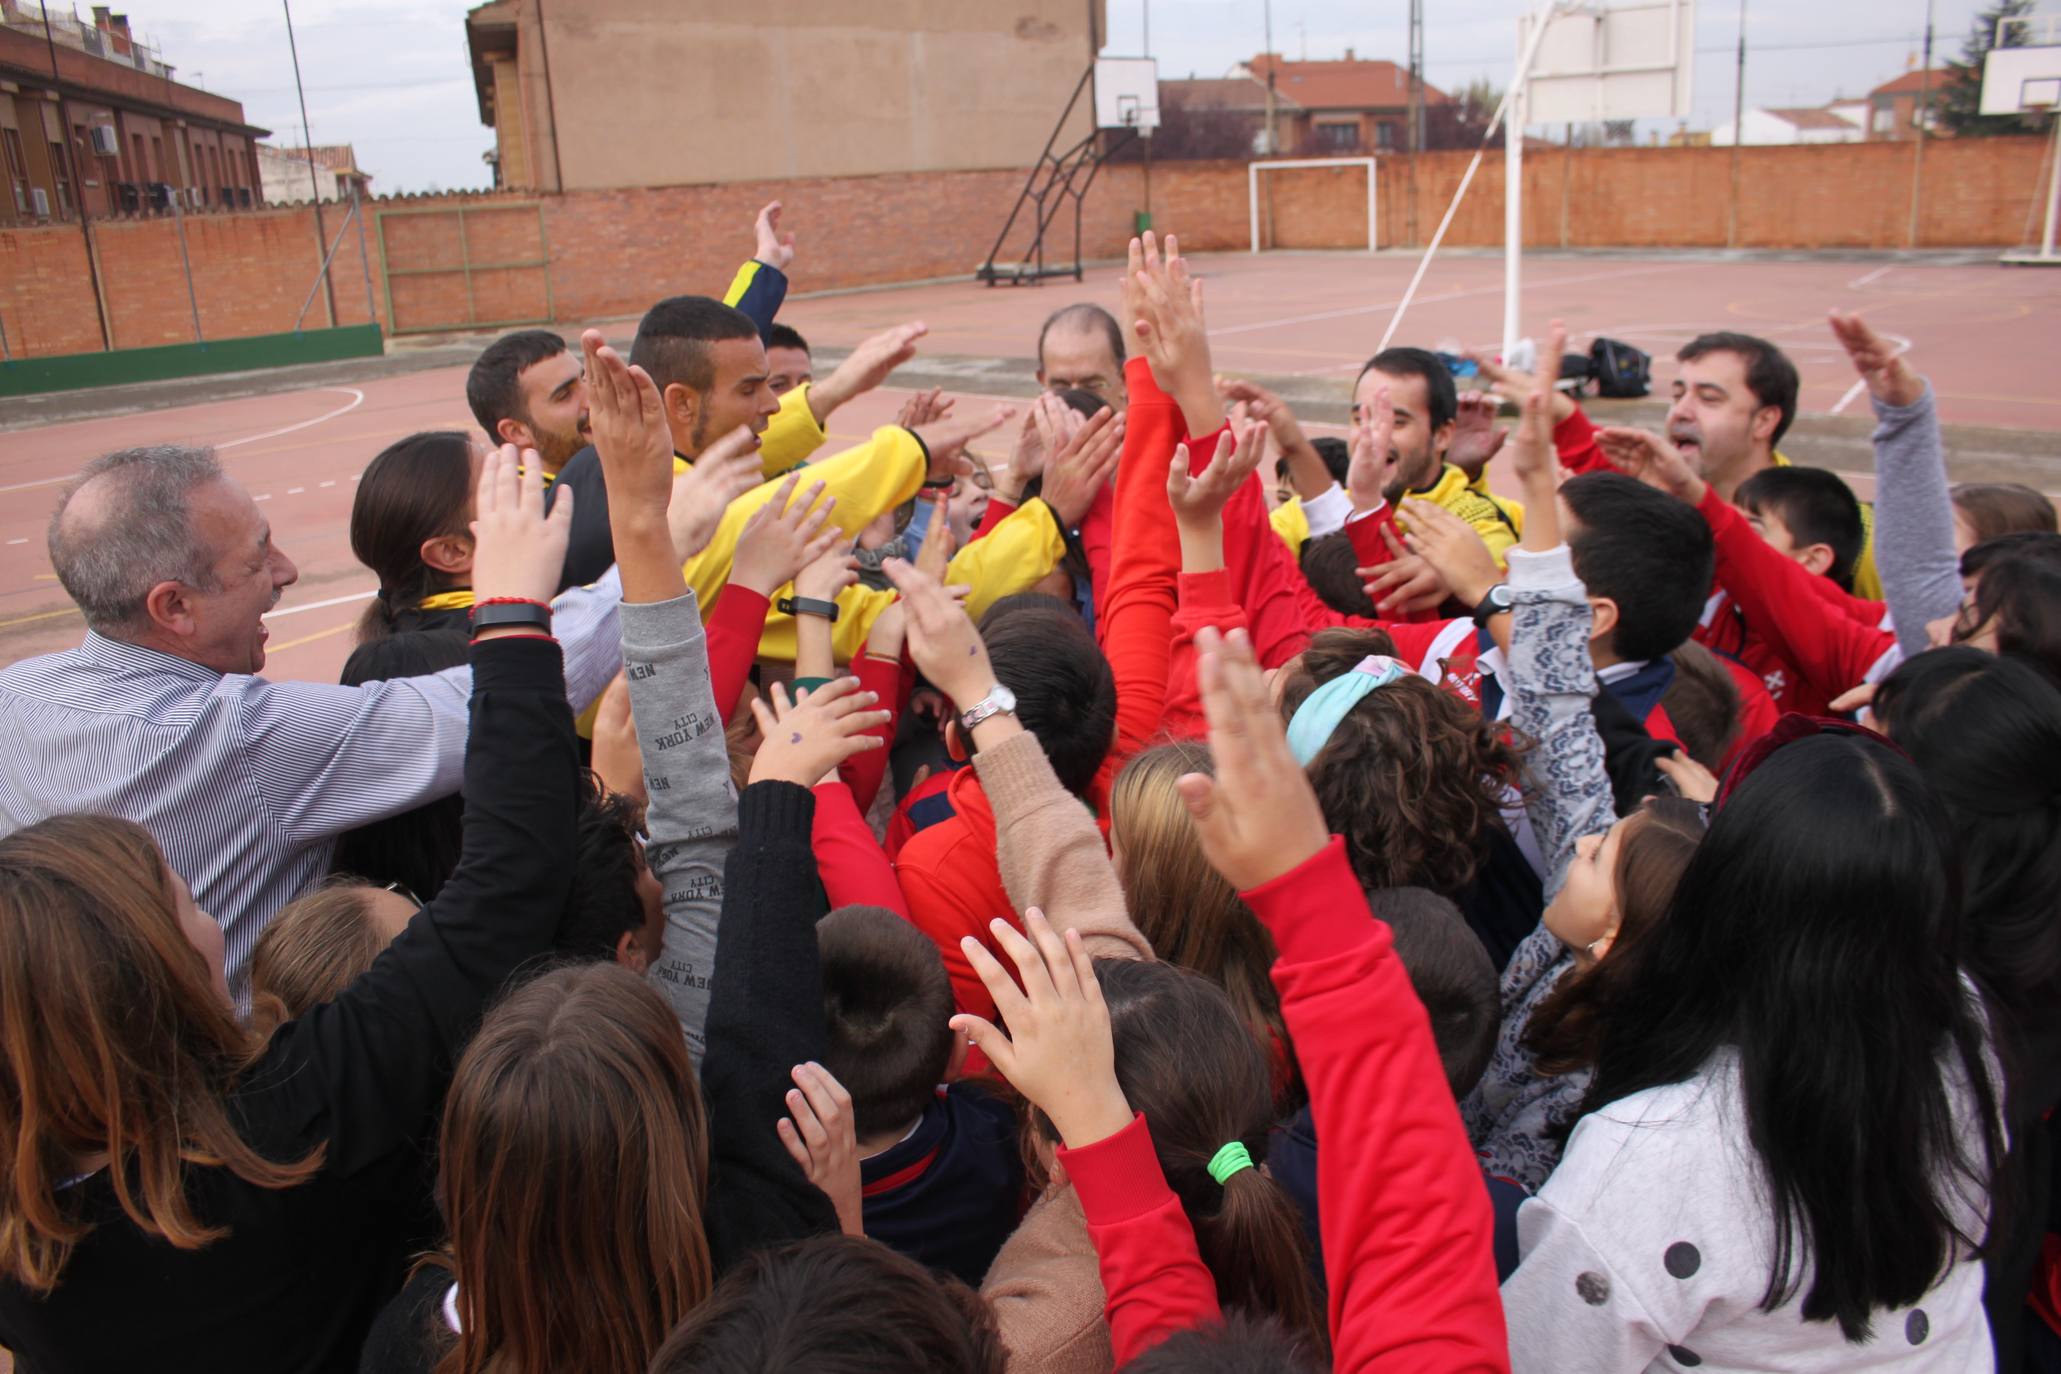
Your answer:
(0, 138), (2042, 354)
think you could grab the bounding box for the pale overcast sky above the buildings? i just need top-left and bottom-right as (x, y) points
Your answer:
(137, 0), (2003, 194)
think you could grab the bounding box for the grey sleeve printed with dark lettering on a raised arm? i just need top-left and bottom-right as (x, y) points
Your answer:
(622, 591), (738, 1069)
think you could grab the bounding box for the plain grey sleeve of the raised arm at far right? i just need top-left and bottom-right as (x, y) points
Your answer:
(1869, 383), (1960, 657)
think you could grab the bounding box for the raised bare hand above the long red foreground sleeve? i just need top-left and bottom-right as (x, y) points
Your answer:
(1187, 626), (1329, 894)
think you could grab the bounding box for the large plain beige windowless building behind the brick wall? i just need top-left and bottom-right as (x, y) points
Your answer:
(466, 0), (1105, 192)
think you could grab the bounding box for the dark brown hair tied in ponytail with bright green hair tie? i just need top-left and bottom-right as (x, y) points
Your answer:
(1094, 960), (1327, 1349)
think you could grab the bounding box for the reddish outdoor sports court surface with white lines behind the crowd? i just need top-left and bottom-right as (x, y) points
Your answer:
(0, 249), (2061, 682)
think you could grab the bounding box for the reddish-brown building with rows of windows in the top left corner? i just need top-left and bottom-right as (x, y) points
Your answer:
(0, 0), (268, 225)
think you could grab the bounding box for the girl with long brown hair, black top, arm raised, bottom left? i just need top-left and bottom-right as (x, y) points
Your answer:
(0, 455), (579, 1374)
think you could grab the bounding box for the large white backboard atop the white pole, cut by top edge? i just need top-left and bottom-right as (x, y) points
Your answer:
(1517, 0), (1696, 124)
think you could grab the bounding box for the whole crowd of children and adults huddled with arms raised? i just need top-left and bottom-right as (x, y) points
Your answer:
(0, 206), (2061, 1374)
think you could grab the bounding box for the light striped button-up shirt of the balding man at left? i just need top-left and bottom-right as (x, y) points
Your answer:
(0, 571), (622, 997)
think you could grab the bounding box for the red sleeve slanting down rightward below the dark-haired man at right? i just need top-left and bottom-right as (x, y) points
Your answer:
(1696, 486), (1896, 696)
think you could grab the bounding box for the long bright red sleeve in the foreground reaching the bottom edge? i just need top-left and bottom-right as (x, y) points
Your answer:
(1243, 836), (1511, 1374)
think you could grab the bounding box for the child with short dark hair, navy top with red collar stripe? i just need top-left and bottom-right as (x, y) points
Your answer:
(816, 906), (1024, 1283)
